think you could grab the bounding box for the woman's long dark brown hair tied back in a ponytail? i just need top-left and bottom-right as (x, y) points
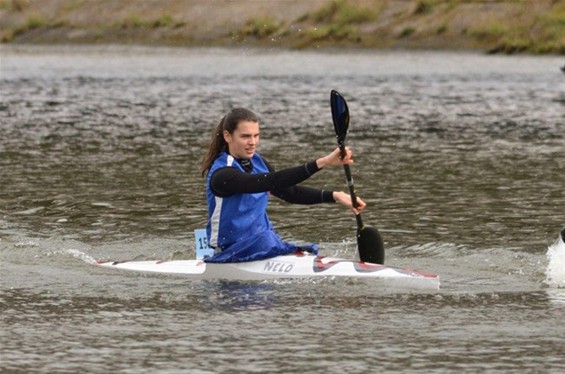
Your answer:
(200, 108), (259, 176)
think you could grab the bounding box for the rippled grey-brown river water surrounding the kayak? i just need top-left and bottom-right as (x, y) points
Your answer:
(0, 46), (565, 373)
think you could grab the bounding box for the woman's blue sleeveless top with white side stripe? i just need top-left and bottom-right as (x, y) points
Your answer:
(205, 152), (318, 263)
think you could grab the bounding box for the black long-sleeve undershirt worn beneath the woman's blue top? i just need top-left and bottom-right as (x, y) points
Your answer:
(210, 159), (335, 204)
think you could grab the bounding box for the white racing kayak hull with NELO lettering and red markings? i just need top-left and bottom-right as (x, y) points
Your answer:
(97, 253), (439, 290)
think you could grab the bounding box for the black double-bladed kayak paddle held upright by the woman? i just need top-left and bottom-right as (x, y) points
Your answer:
(330, 90), (385, 264)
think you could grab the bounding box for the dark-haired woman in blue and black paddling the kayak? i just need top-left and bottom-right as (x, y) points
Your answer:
(202, 108), (366, 263)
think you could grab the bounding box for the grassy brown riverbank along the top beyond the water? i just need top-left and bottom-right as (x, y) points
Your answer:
(0, 0), (565, 54)
